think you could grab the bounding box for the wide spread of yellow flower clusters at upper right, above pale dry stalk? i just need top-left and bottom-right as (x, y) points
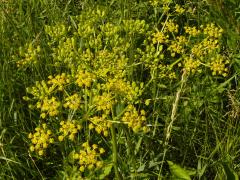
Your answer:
(135, 10), (226, 79)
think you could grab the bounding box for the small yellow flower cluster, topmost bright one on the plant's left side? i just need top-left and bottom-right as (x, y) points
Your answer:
(47, 73), (70, 91)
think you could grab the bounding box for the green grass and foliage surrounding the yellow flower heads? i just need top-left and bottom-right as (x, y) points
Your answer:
(0, 0), (240, 179)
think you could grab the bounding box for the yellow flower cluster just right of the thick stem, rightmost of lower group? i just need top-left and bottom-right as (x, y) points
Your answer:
(122, 104), (149, 132)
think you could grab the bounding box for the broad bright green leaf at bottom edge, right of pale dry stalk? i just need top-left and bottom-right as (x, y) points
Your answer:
(167, 161), (191, 180)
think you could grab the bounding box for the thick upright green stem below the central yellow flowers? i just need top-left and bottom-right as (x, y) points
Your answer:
(111, 124), (122, 180)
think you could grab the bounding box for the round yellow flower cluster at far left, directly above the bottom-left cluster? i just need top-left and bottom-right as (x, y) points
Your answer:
(37, 97), (61, 119)
